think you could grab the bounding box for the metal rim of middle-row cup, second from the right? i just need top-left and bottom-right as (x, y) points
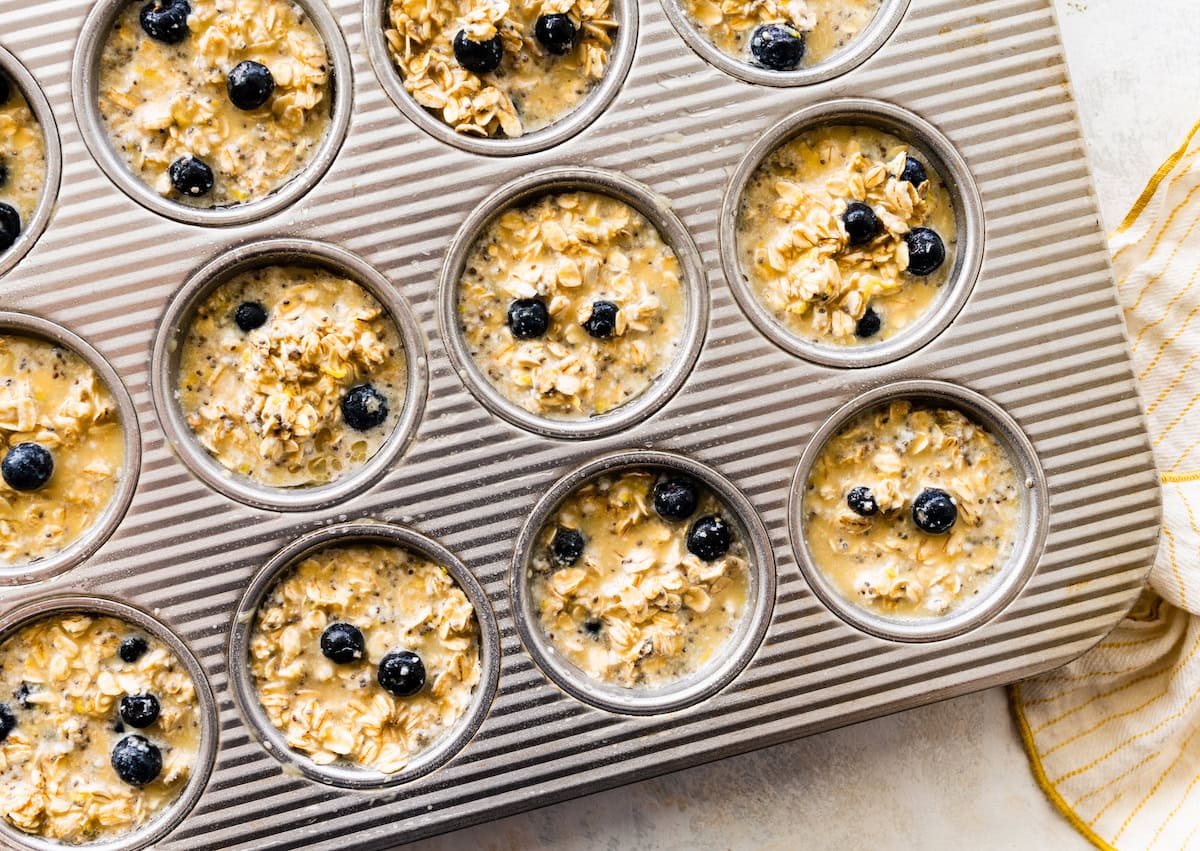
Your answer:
(438, 167), (709, 439)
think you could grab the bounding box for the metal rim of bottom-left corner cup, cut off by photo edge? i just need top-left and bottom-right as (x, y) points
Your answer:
(0, 593), (220, 851)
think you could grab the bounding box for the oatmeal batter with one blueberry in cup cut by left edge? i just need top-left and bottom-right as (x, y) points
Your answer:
(0, 334), (125, 564)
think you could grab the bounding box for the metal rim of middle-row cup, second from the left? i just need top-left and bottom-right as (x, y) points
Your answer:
(150, 239), (428, 511)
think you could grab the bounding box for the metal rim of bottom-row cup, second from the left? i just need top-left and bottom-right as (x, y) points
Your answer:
(227, 521), (500, 791)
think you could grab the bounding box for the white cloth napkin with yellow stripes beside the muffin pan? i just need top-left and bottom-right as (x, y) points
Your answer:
(1012, 125), (1200, 851)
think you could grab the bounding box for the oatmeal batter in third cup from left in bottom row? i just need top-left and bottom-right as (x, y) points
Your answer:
(529, 471), (749, 688)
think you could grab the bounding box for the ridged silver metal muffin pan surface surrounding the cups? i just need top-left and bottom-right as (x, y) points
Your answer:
(0, 0), (1159, 851)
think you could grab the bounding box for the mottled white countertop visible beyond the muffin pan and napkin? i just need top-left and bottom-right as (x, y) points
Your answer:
(409, 0), (1200, 851)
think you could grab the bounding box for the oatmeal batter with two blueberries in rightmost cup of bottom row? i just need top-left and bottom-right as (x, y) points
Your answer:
(802, 401), (1022, 617)
